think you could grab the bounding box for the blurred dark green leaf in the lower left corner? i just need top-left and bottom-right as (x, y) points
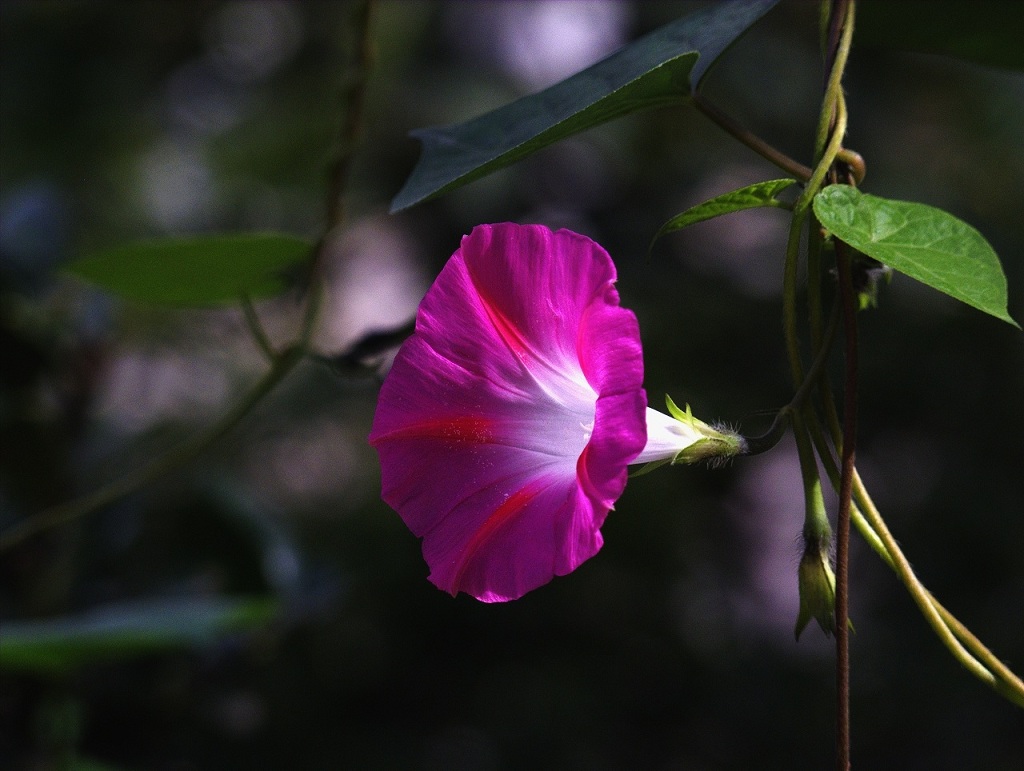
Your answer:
(0, 597), (278, 673)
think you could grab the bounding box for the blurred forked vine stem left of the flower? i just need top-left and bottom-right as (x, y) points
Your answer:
(0, 0), (373, 552)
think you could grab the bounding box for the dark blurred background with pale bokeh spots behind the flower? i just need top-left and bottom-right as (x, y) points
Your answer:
(0, 0), (1024, 771)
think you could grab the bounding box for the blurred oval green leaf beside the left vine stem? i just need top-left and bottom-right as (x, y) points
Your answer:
(66, 233), (312, 307)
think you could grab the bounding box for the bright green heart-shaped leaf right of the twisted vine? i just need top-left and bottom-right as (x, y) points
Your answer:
(814, 184), (1019, 327)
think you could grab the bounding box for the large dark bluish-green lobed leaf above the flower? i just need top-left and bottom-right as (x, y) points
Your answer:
(391, 0), (778, 212)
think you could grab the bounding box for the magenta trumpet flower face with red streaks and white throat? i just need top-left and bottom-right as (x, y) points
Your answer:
(370, 223), (647, 602)
